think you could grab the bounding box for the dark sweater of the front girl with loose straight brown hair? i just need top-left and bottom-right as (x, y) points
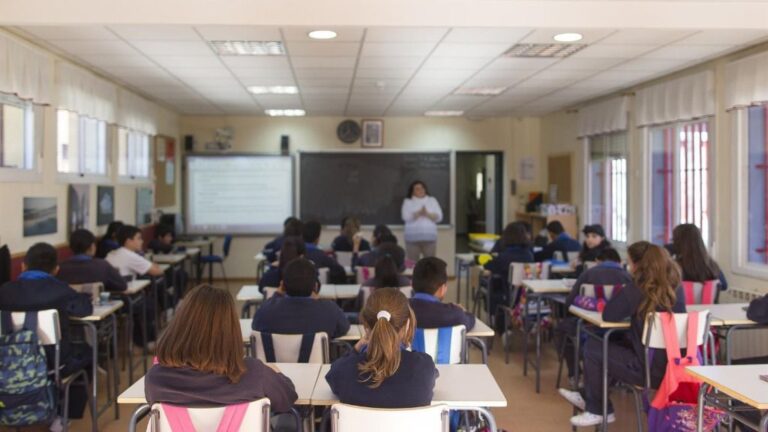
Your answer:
(144, 357), (298, 412)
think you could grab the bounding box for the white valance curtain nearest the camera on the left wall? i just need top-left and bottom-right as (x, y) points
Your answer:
(0, 33), (53, 104)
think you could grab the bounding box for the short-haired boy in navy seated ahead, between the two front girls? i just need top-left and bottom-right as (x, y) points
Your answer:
(251, 258), (349, 339)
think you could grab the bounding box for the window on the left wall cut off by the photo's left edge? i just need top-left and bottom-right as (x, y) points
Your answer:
(0, 95), (35, 170)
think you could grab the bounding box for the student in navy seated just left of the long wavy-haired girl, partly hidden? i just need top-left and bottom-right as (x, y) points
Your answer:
(555, 247), (632, 379)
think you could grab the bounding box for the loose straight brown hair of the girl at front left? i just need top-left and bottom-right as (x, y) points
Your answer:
(157, 285), (246, 383)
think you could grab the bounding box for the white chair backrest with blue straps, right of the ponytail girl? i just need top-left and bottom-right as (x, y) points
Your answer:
(411, 324), (467, 364)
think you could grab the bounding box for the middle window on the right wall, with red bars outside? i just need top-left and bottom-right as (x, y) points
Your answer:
(650, 120), (711, 244)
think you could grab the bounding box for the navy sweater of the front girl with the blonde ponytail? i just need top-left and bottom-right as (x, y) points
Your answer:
(325, 348), (438, 408)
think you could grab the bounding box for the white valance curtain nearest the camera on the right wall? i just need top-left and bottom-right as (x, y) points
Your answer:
(725, 52), (768, 109)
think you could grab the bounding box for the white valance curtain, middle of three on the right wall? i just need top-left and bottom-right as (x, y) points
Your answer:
(635, 71), (715, 126)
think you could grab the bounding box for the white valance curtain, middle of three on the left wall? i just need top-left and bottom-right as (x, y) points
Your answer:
(56, 61), (117, 123)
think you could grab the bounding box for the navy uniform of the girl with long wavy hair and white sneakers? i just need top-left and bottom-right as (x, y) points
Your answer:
(583, 283), (686, 415)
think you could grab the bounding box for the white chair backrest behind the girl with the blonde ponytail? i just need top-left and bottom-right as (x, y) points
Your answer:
(331, 404), (450, 432)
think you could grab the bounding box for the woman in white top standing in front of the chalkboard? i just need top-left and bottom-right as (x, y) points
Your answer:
(400, 180), (443, 261)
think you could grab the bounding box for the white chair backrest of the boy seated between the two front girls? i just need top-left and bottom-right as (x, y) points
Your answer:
(251, 331), (329, 363)
